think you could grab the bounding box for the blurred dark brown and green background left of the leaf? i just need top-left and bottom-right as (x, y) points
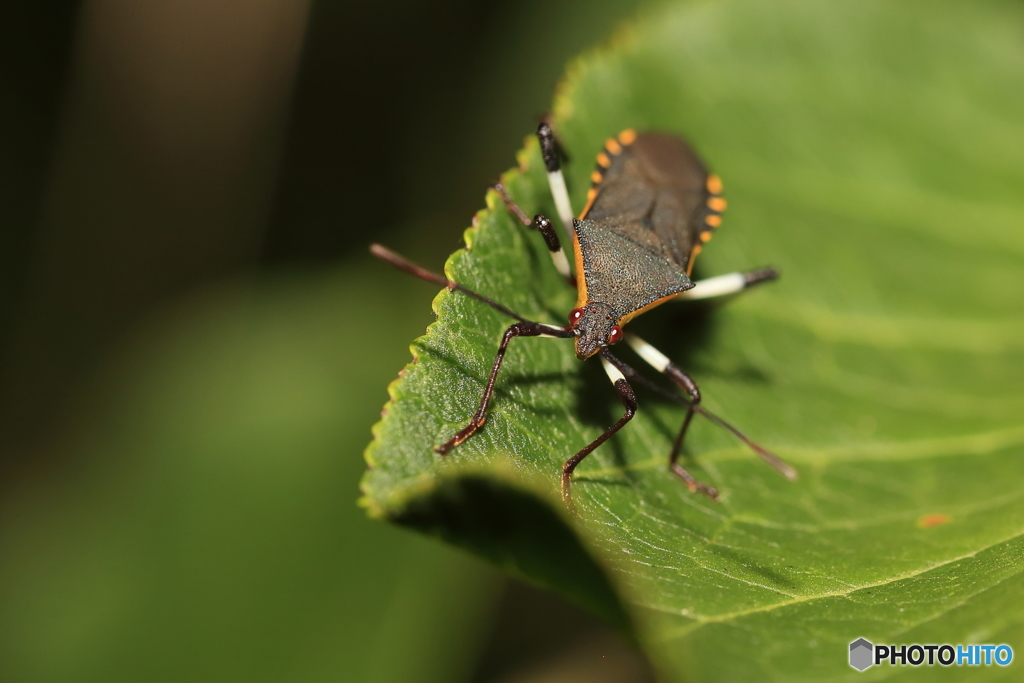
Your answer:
(0, 0), (651, 681)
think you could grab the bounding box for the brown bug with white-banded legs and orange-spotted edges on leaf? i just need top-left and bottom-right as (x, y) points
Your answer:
(371, 123), (797, 503)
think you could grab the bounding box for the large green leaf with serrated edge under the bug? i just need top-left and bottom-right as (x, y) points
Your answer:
(364, 0), (1024, 681)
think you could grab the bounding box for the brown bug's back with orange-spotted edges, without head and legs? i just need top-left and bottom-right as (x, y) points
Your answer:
(577, 133), (724, 321)
